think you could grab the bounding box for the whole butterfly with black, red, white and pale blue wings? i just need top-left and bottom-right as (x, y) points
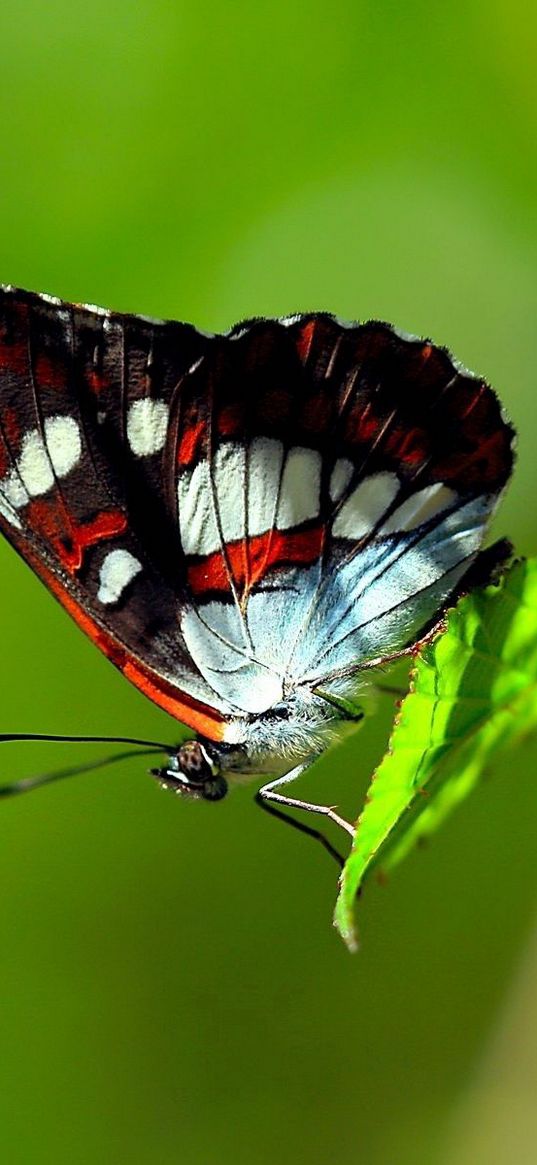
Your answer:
(0, 287), (514, 832)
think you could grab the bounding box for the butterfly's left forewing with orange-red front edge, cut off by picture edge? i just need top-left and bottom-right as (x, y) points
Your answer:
(0, 288), (228, 737)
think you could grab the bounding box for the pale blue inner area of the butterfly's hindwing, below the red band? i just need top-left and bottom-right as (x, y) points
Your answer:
(182, 495), (495, 714)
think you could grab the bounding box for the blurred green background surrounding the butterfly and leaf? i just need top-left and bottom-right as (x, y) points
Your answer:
(0, 0), (537, 1165)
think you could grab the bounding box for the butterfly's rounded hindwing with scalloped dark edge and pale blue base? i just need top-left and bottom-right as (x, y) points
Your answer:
(176, 315), (514, 712)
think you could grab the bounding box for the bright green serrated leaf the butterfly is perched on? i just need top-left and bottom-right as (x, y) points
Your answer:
(334, 559), (537, 949)
